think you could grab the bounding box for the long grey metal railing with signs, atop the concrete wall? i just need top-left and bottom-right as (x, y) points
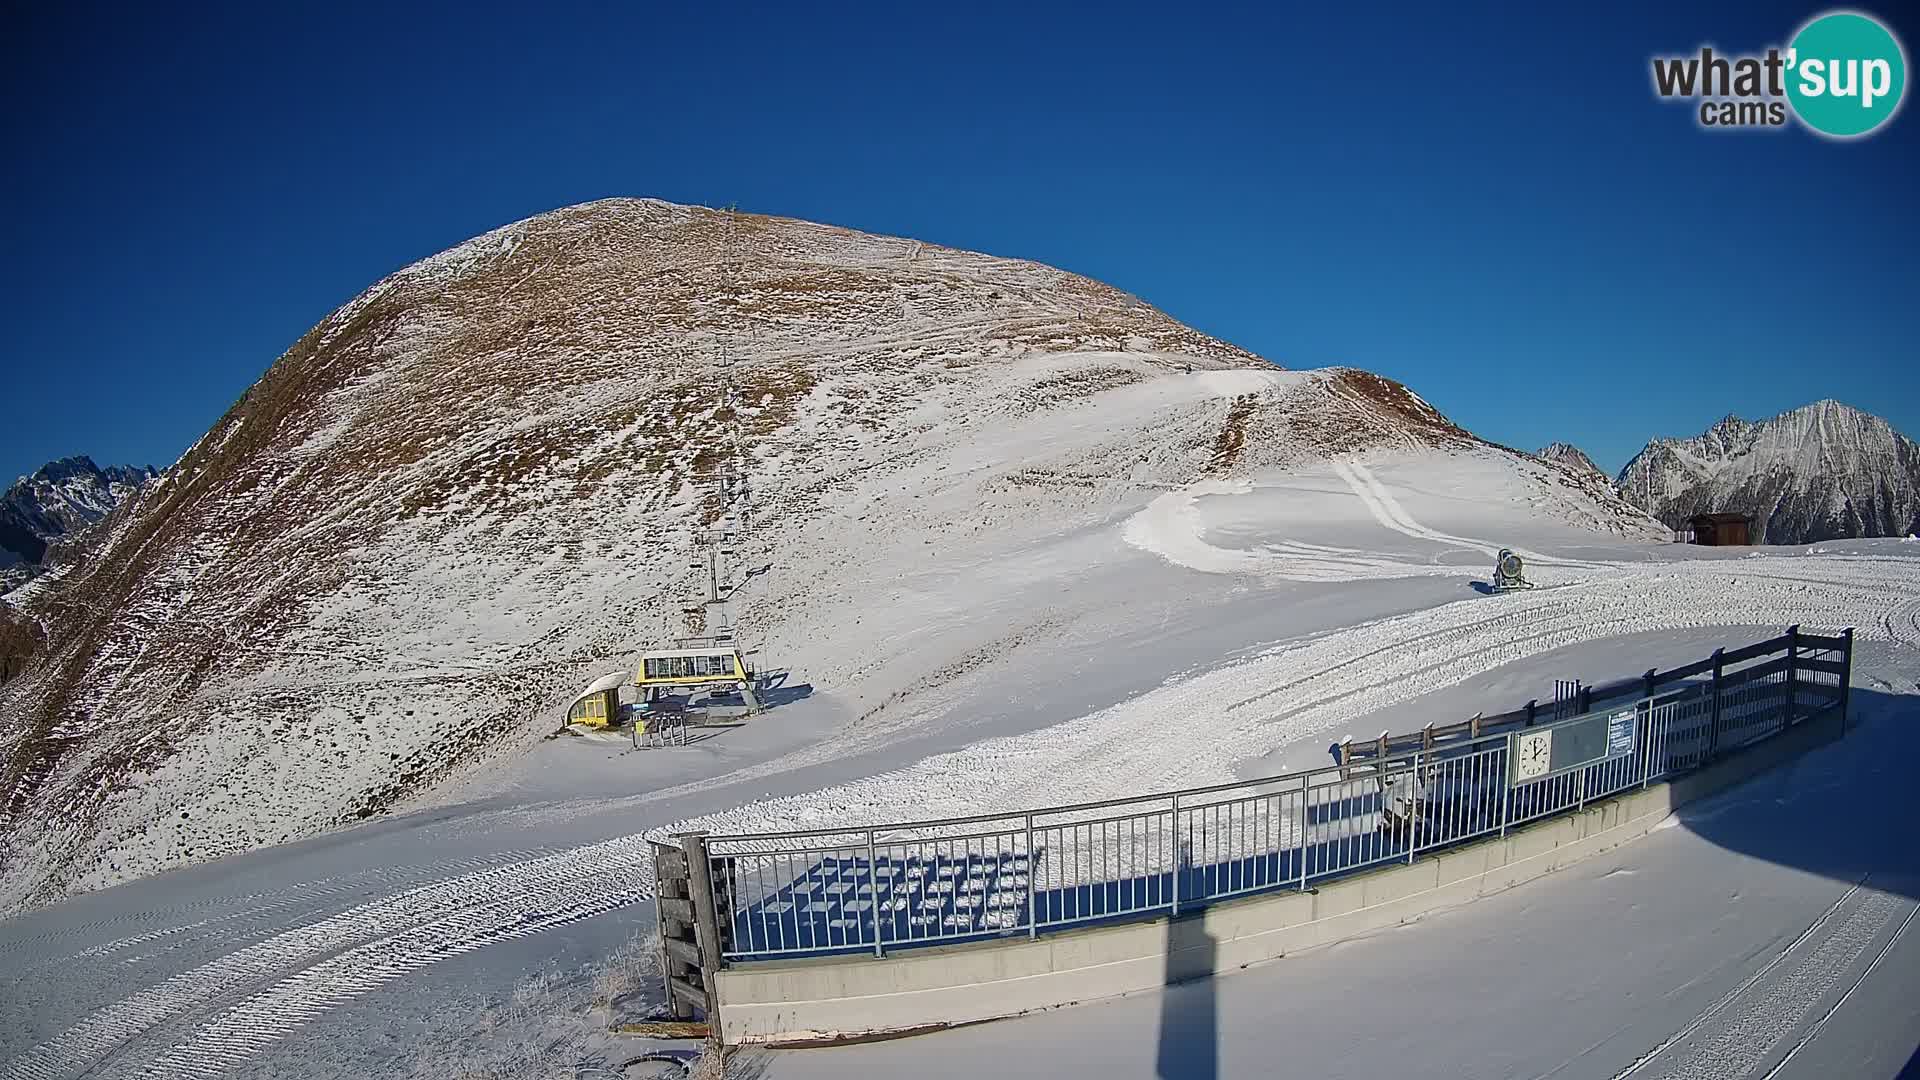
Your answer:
(680, 626), (1853, 963)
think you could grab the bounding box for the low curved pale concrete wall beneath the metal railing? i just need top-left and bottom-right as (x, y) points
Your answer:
(714, 709), (1841, 1045)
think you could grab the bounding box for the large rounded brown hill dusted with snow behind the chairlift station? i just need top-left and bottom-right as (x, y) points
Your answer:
(0, 200), (1645, 907)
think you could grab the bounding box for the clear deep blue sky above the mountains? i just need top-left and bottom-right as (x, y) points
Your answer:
(0, 4), (1920, 475)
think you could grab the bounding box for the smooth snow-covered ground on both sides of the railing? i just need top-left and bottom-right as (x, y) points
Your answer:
(0, 441), (1920, 1080)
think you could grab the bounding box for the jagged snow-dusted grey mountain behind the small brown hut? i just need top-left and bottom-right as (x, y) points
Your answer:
(1619, 402), (1920, 544)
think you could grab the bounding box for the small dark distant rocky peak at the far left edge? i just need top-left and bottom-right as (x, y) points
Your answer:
(0, 455), (157, 592)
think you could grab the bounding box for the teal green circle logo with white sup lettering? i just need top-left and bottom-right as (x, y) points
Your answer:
(1788, 12), (1907, 138)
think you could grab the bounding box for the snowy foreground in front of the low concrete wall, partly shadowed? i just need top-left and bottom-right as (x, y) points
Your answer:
(743, 659), (1920, 1080)
